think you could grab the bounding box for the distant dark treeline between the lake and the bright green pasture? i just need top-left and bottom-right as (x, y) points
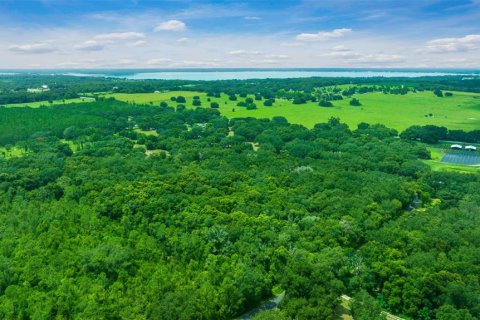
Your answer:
(0, 75), (480, 105)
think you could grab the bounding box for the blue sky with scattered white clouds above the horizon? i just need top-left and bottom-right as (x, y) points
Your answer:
(0, 0), (480, 69)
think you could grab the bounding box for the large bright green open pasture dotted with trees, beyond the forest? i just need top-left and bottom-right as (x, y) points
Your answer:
(106, 91), (480, 131)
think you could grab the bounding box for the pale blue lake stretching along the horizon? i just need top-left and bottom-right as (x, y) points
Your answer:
(0, 68), (480, 80)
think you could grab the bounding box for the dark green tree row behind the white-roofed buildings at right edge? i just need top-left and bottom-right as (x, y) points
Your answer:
(400, 125), (480, 144)
